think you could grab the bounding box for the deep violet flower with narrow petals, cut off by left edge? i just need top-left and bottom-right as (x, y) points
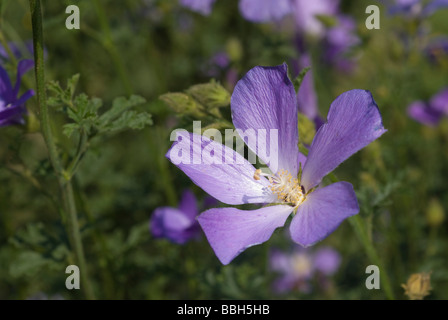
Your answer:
(0, 60), (34, 127)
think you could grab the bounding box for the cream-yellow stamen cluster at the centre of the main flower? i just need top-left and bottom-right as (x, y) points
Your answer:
(254, 169), (306, 208)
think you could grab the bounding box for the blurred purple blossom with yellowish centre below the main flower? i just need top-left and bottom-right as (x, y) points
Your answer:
(269, 247), (341, 293)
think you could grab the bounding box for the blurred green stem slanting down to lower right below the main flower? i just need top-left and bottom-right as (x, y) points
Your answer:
(328, 173), (394, 300)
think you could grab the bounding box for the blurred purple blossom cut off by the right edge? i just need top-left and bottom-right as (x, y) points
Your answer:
(408, 88), (448, 126)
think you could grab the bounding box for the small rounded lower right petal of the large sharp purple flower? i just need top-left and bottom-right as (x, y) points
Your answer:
(290, 182), (359, 247)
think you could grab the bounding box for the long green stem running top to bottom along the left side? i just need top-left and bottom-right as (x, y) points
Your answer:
(29, 0), (94, 299)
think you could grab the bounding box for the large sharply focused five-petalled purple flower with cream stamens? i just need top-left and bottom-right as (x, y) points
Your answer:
(167, 64), (386, 264)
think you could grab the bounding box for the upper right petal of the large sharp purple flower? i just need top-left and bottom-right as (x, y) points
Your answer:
(301, 89), (386, 191)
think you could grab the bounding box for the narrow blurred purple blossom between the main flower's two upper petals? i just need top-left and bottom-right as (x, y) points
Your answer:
(297, 53), (324, 131)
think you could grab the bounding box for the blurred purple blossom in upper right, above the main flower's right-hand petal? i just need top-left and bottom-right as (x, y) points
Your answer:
(324, 15), (360, 72)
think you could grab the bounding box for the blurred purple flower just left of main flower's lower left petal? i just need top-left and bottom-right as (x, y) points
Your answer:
(150, 190), (201, 244)
